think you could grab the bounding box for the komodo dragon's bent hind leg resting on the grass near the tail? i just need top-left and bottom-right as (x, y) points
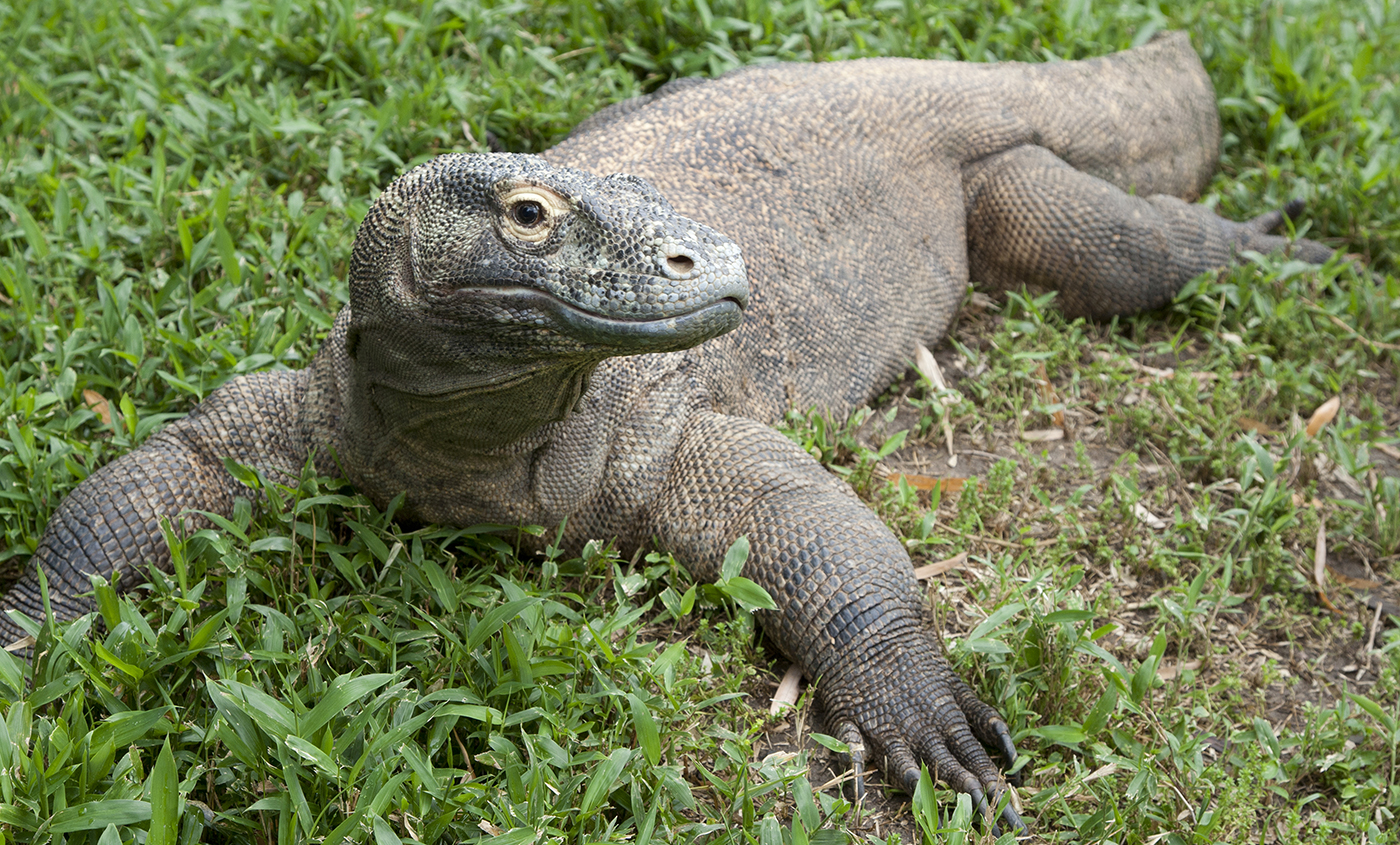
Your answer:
(963, 145), (1331, 318)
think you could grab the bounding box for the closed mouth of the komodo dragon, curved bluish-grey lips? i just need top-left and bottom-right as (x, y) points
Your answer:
(454, 285), (748, 354)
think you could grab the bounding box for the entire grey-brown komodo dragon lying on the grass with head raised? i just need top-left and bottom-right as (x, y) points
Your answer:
(0, 34), (1330, 827)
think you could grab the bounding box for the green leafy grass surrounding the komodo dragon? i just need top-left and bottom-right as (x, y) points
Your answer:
(0, 0), (1400, 845)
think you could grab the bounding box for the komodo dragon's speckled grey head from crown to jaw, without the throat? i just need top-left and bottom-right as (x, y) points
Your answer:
(350, 154), (749, 357)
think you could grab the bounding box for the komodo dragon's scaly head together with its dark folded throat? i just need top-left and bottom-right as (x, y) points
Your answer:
(344, 154), (749, 449)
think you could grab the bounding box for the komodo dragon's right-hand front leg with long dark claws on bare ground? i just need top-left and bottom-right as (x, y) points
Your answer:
(652, 413), (1023, 828)
